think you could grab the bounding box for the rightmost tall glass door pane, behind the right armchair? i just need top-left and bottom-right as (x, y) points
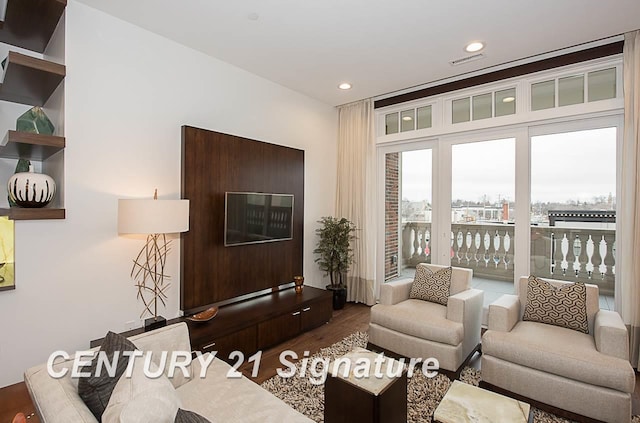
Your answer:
(530, 127), (618, 310)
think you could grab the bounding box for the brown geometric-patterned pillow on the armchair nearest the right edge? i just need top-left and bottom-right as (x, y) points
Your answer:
(522, 276), (589, 333)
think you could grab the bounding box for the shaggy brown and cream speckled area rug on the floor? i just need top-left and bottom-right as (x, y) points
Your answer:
(261, 332), (640, 423)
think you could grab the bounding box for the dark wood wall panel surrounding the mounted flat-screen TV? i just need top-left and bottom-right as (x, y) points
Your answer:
(180, 126), (304, 313)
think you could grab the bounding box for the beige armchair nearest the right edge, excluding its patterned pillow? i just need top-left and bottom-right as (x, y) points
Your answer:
(480, 277), (635, 423)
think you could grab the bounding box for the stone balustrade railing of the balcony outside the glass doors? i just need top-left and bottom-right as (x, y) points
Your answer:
(402, 222), (615, 295)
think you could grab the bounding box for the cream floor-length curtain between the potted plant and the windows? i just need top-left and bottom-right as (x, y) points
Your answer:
(336, 99), (376, 305)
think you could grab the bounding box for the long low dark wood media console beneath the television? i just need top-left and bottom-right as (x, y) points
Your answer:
(90, 286), (333, 361)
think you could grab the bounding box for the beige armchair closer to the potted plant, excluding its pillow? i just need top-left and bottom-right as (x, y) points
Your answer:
(369, 263), (484, 378)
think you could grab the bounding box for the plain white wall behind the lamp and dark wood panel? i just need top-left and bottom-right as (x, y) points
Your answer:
(0, 0), (337, 386)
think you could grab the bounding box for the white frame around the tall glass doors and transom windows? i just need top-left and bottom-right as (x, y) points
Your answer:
(376, 55), (624, 309)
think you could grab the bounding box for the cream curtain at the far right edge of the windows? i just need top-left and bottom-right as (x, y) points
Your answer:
(616, 31), (640, 367)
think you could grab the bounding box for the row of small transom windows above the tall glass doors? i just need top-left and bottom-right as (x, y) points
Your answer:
(380, 59), (622, 135)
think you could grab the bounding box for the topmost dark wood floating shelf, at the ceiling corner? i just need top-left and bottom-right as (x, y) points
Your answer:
(0, 0), (67, 52)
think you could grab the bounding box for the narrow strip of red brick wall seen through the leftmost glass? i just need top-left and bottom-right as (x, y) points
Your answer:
(384, 153), (400, 280)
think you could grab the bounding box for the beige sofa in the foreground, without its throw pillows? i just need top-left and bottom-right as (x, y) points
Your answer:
(24, 323), (311, 423)
